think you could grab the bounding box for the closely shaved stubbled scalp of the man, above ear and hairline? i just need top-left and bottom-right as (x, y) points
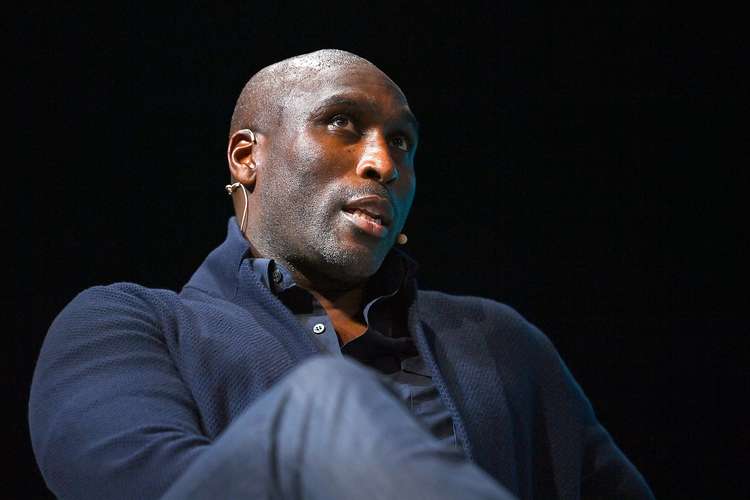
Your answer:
(229, 49), (379, 136)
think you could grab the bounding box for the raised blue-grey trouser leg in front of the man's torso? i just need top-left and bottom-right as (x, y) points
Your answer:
(165, 357), (512, 500)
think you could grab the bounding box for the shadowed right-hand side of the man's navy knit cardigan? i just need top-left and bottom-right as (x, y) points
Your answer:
(420, 292), (653, 500)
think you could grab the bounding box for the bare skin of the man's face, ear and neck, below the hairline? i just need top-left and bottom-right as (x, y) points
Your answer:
(227, 62), (417, 344)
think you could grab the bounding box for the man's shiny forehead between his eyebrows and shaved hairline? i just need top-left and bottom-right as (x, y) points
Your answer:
(285, 64), (413, 123)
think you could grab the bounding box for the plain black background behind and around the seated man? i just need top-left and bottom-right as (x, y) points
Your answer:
(17, 2), (750, 498)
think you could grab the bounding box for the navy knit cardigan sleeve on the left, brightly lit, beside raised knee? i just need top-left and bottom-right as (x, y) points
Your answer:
(29, 285), (209, 499)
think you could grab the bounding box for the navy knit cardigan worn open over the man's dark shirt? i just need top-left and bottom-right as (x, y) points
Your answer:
(29, 218), (652, 499)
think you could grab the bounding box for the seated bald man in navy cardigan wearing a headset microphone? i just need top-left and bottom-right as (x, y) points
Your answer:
(30, 50), (652, 499)
